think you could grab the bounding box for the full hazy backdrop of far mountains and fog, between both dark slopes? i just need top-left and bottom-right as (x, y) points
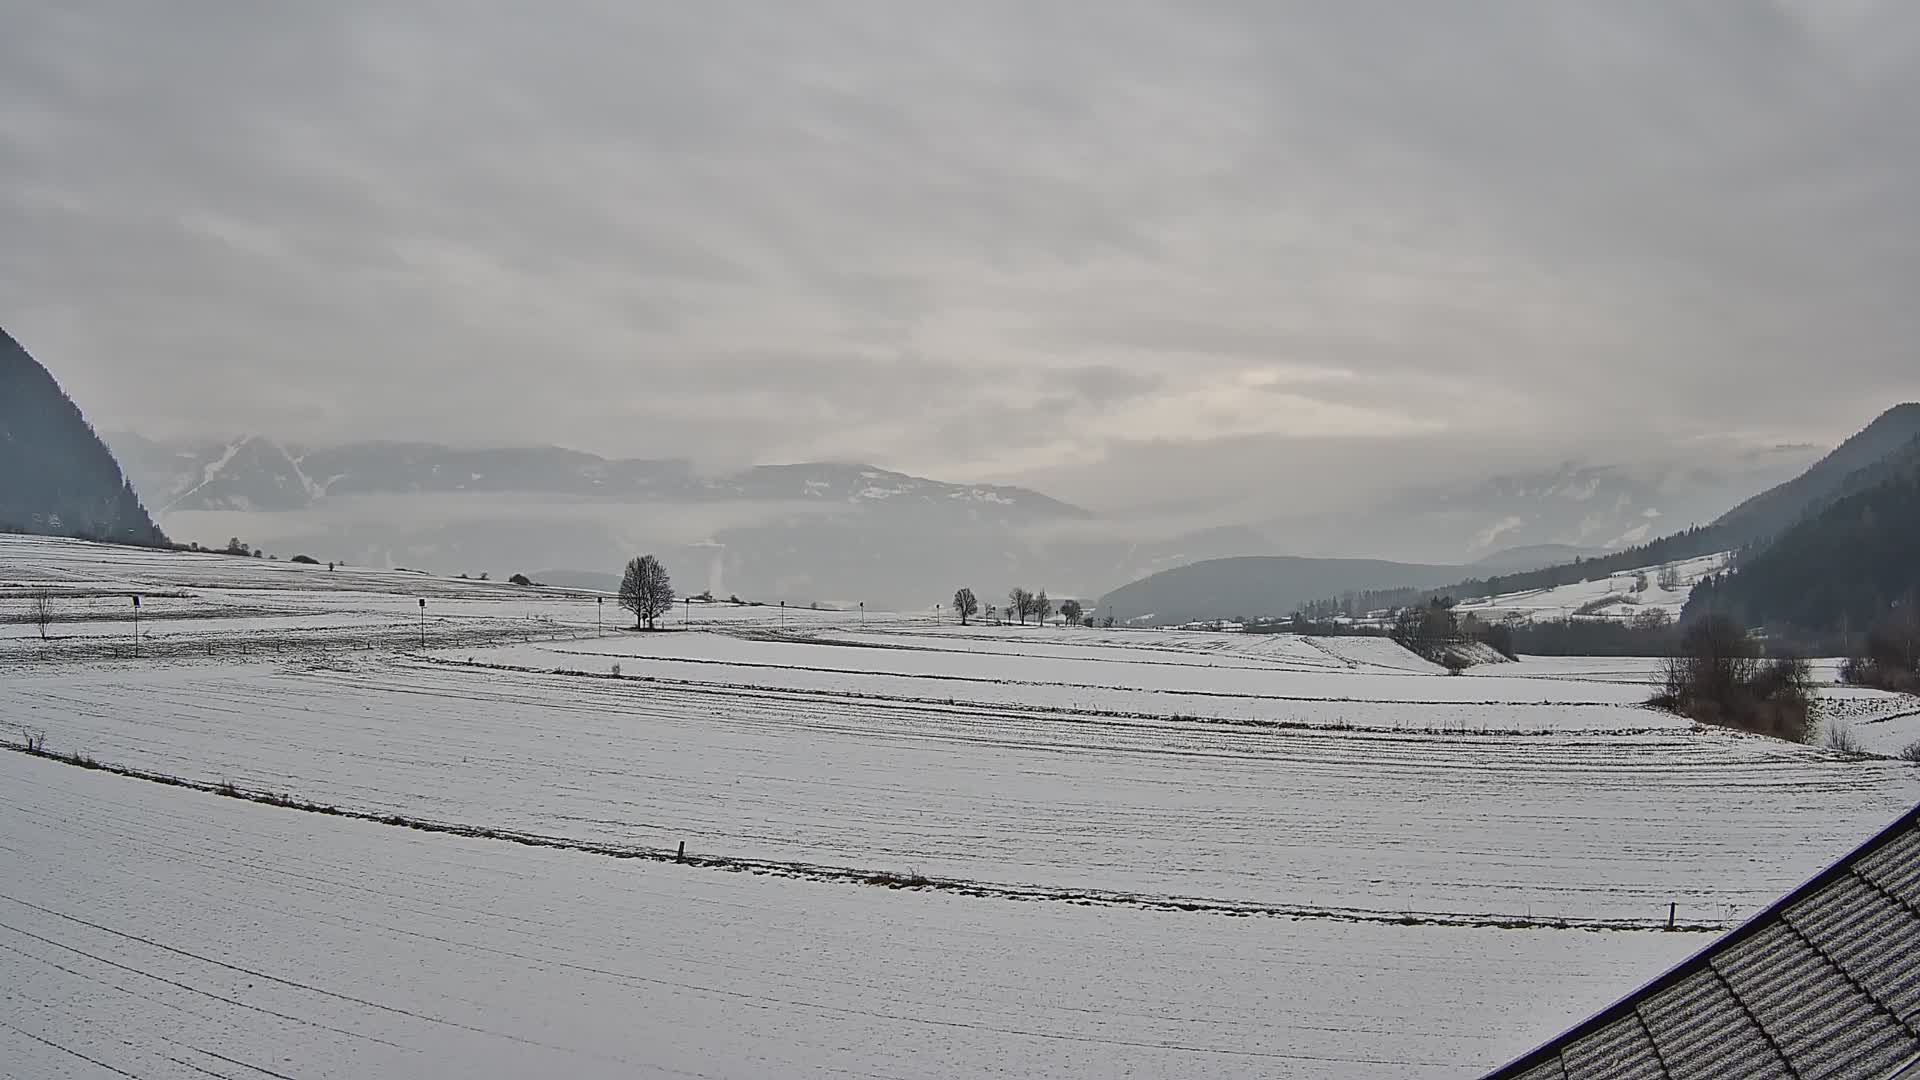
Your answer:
(111, 417), (1843, 615)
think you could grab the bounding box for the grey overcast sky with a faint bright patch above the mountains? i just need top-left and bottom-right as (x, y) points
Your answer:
(0, 0), (1920, 502)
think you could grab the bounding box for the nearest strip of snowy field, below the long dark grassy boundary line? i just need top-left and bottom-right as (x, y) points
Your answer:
(0, 753), (1701, 1080)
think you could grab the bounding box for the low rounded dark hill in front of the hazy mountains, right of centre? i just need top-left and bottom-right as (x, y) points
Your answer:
(1100, 555), (1461, 625)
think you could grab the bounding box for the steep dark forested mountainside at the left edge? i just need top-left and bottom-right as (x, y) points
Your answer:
(0, 331), (165, 544)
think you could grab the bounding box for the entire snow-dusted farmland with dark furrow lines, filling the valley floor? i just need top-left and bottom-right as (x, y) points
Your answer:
(11, 536), (1920, 1078)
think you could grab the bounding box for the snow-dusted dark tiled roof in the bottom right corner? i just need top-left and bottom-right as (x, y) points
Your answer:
(1488, 807), (1920, 1080)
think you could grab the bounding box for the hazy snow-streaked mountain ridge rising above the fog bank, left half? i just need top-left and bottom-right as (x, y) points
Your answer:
(113, 434), (1091, 519)
